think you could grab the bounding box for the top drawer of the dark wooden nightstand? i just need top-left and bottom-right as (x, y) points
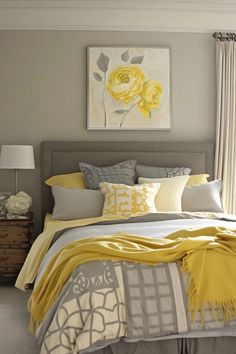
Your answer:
(0, 226), (29, 245)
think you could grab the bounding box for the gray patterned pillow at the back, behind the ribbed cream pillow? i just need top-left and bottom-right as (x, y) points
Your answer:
(136, 164), (191, 178)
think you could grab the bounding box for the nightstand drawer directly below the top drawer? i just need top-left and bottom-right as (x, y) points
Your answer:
(0, 249), (27, 267)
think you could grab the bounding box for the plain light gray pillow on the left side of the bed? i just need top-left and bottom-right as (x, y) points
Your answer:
(52, 186), (104, 220)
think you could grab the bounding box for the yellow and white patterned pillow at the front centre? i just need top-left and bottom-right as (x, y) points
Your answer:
(100, 182), (160, 216)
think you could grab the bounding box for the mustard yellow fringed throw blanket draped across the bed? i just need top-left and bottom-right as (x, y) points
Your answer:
(29, 227), (236, 328)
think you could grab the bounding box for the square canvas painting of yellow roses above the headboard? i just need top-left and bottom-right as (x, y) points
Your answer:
(87, 47), (170, 130)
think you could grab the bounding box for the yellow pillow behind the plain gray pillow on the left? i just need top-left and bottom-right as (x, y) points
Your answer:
(45, 172), (86, 189)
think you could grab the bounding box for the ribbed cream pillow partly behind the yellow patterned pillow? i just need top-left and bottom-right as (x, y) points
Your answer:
(138, 175), (189, 211)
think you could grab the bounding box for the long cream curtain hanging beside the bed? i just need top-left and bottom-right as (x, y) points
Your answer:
(215, 40), (236, 214)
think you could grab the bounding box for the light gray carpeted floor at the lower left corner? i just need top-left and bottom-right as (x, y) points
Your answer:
(0, 286), (40, 354)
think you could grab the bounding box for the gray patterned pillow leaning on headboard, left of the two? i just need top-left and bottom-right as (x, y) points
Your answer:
(79, 160), (136, 189)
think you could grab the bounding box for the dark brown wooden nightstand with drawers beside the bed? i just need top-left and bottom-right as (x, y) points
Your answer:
(0, 213), (33, 283)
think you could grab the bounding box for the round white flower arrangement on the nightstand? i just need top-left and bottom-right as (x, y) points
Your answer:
(6, 192), (32, 215)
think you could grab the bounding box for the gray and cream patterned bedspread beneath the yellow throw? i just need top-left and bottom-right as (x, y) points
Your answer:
(31, 213), (236, 354)
